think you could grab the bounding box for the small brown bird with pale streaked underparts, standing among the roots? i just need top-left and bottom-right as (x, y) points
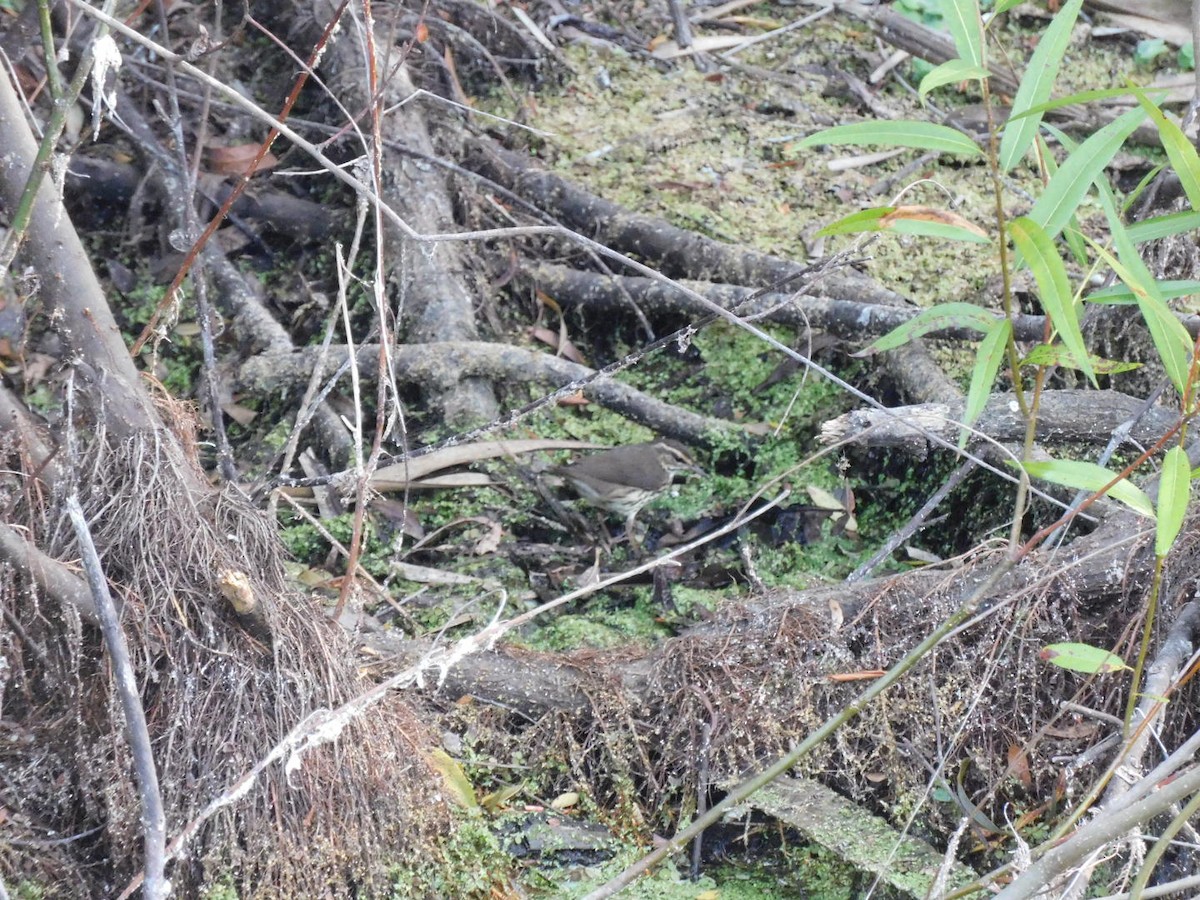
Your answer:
(550, 440), (703, 541)
